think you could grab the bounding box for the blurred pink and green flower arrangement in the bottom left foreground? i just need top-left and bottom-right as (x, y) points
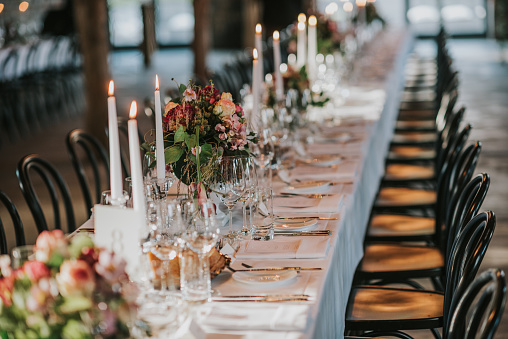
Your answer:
(0, 230), (137, 339)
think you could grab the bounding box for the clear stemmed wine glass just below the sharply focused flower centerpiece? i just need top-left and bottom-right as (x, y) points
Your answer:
(210, 155), (245, 238)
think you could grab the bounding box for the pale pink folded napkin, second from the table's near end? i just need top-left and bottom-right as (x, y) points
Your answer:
(235, 237), (330, 259)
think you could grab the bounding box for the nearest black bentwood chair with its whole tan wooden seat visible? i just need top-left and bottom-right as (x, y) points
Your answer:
(346, 212), (496, 338)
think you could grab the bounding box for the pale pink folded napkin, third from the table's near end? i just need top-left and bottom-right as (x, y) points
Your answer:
(273, 194), (342, 214)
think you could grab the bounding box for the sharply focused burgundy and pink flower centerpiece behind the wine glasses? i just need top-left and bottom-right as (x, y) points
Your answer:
(143, 83), (255, 199)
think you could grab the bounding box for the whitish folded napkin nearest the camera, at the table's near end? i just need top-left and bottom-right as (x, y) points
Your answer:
(198, 303), (309, 331)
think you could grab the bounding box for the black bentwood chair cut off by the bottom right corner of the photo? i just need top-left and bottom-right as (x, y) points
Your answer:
(345, 269), (506, 339)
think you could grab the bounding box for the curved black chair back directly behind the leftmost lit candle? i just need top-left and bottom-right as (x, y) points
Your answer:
(65, 129), (109, 216)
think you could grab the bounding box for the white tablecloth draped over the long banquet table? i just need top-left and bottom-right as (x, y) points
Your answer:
(191, 31), (412, 338)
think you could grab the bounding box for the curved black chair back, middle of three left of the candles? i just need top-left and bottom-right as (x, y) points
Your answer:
(16, 154), (76, 233)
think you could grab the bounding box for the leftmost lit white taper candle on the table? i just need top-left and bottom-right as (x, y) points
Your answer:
(108, 80), (123, 201)
